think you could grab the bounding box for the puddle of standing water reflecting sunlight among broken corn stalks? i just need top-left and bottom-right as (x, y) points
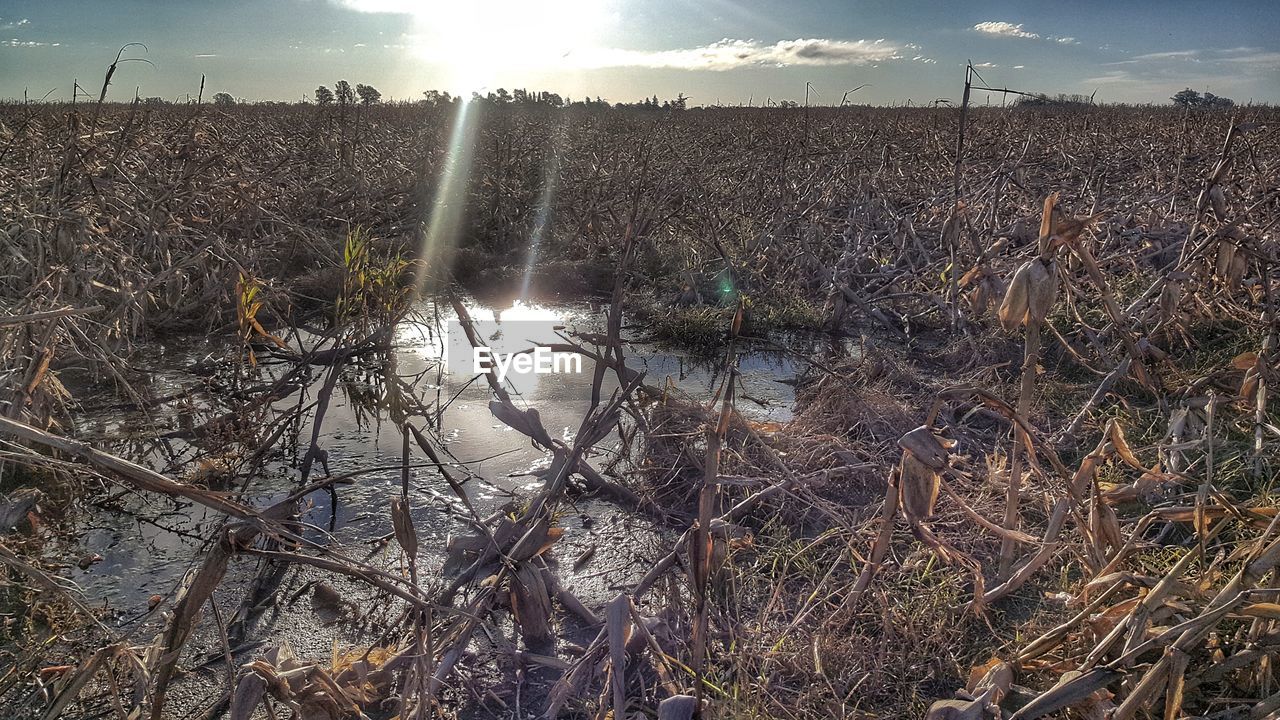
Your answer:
(62, 294), (803, 620)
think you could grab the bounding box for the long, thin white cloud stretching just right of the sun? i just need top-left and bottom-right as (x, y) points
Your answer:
(566, 38), (906, 70)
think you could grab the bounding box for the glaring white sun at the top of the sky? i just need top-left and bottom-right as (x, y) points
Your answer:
(412, 0), (612, 91)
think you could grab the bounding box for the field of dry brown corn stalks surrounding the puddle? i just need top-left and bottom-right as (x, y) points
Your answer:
(0, 96), (1280, 720)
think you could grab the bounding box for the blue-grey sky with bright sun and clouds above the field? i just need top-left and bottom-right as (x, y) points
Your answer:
(0, 0), (1280, 105)
